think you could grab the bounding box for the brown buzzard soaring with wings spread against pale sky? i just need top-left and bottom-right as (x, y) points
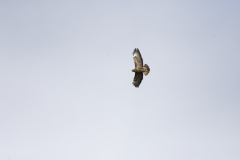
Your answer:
(132, 48), (150, 87)
